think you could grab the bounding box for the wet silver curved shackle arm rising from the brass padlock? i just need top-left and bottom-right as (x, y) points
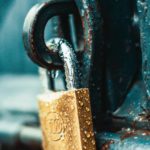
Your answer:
(47, 38), (80, 90)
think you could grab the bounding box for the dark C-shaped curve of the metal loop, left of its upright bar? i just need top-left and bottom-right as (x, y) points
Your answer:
(23, 0), (77, 69)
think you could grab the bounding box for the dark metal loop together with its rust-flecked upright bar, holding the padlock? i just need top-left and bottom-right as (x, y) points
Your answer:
(23, 0), (103, 87)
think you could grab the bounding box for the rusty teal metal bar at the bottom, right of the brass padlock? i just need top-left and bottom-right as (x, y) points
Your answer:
(97, 129), (150, 150)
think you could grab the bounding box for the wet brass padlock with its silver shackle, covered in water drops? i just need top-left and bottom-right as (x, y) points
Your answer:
(39, 38), (96, 150)
